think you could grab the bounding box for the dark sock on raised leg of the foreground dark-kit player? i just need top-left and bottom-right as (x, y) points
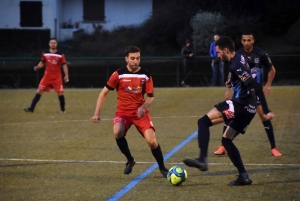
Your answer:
(198, 115), (212, 162)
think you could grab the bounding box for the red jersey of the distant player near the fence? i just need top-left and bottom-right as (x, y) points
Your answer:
(42, 51), (66, 76)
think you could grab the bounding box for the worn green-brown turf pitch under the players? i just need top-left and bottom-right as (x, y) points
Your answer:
(0, 86), (300, 201)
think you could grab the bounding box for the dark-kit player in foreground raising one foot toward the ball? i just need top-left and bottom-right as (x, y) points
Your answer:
(183, 37), (274, 186)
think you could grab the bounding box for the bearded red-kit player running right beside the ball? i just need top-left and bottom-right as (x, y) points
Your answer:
(92, 46), (168, 177)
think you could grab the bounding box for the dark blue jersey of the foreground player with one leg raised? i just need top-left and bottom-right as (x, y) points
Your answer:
(229, 54), (256, 105)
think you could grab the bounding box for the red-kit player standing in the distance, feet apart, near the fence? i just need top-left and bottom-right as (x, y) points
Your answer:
(24, 38), (69, 113)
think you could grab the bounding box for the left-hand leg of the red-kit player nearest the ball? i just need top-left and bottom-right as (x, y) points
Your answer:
(113, 116), (135, 174)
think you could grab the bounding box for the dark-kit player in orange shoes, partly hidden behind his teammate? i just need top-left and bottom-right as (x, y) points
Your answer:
(214, 33), (281, 156)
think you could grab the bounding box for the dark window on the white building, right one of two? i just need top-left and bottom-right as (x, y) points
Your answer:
(83, 0), (105, 22)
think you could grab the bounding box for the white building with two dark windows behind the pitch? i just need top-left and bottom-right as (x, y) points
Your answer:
(0, 0), (152, 41)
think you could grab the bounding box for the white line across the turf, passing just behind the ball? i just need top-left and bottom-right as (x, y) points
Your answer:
(0, 158), (300, 166)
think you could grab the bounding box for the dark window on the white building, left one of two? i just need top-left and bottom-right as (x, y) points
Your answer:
(20, 1), (43, 27)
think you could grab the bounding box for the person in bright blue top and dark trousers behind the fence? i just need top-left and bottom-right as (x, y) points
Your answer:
(209, 34), (224, 86)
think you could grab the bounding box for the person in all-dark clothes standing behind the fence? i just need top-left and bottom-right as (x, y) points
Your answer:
(181, 40), (195, 87)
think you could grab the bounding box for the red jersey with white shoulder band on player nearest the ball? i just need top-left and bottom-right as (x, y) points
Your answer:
(106, 67), (154, 111)
